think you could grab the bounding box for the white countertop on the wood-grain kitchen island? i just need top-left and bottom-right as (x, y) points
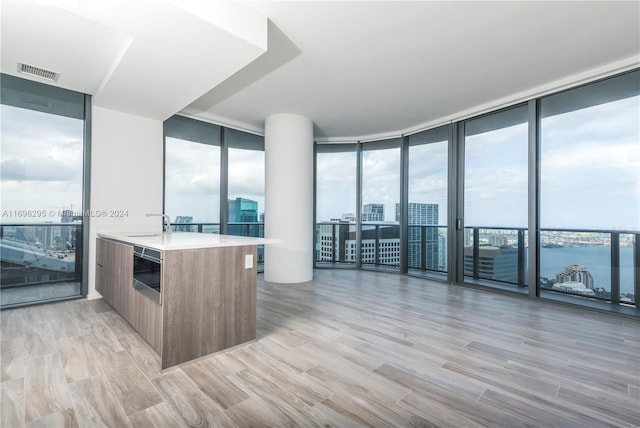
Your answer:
(97, 232), (282, 251)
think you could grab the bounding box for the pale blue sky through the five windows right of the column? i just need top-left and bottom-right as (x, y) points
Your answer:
(316, 96), (640, 230)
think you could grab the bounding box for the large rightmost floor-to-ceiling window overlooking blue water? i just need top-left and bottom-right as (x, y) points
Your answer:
(539, 71), (640, 304)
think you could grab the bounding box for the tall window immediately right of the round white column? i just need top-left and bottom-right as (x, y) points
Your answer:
(315, 144), (357, 266)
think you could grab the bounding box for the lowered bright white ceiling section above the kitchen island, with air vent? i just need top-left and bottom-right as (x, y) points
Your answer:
(1, 0), (267, 120)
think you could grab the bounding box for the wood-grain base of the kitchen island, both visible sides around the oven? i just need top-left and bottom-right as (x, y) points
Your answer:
(96, 238), (257, 369)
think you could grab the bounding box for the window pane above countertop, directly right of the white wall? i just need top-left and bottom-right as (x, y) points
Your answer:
(164, 137), (220, 227)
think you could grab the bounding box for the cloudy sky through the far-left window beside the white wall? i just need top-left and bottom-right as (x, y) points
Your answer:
(0, 105), (84, 224)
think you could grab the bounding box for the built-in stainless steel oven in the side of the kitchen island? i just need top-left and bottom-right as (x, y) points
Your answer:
(133, 245), (162, 304)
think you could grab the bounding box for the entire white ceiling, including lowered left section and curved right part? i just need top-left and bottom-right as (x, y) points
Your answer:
(2, 0), (640, 139)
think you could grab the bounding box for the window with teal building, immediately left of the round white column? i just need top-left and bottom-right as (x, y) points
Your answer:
(224, 128), (264, 263)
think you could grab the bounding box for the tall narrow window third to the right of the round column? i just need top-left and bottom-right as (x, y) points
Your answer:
(406, 126), (449, 279)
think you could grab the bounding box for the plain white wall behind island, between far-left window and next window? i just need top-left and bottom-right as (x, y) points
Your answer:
(86, 106), (163, 299)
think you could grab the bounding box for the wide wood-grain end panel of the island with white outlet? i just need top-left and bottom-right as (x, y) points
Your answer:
(162, 245), (257, 368)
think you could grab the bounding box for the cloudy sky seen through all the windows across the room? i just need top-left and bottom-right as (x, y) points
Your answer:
(0, 97), (640, 230)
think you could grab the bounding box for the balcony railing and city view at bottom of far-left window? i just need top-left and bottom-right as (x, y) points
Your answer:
(0, 223), (82, 288)
